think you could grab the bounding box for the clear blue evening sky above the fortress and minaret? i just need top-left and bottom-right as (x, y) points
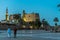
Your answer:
(0, 0), (60, 25)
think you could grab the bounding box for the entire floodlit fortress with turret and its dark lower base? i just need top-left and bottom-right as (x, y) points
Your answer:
(22, 10), (40, 29)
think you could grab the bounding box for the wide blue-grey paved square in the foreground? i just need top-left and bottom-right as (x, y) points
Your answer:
(0, 30), (60, 40)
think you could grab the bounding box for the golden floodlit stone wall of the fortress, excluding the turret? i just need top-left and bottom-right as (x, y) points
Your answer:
(23, 14), (39, 22)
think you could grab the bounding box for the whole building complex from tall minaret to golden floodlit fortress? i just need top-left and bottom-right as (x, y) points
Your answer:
(1, 8), (40, 29)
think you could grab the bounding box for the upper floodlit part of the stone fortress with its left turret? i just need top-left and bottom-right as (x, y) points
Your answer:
(23, 11), (40, 22)
